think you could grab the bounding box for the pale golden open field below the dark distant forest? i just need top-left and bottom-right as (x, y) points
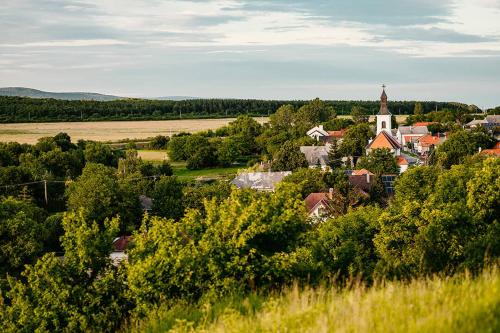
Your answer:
(0, 118), (267, 144)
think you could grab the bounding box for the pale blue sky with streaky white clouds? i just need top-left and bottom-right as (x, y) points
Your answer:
(0, 0), (500, 108)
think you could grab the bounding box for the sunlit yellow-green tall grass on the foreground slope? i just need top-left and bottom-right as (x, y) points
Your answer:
(131, 269), (500, 332)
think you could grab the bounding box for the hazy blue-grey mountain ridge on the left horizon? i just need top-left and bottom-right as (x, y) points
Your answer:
(0, 87), (198, 102)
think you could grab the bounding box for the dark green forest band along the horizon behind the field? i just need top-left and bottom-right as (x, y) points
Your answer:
(0, 96), (478, 123)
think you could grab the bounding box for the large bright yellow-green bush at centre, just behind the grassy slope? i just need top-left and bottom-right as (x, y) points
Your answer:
(127, 187), (306, 310)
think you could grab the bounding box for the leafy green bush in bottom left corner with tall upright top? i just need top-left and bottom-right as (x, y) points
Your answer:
(0, 214), (128, 332)
